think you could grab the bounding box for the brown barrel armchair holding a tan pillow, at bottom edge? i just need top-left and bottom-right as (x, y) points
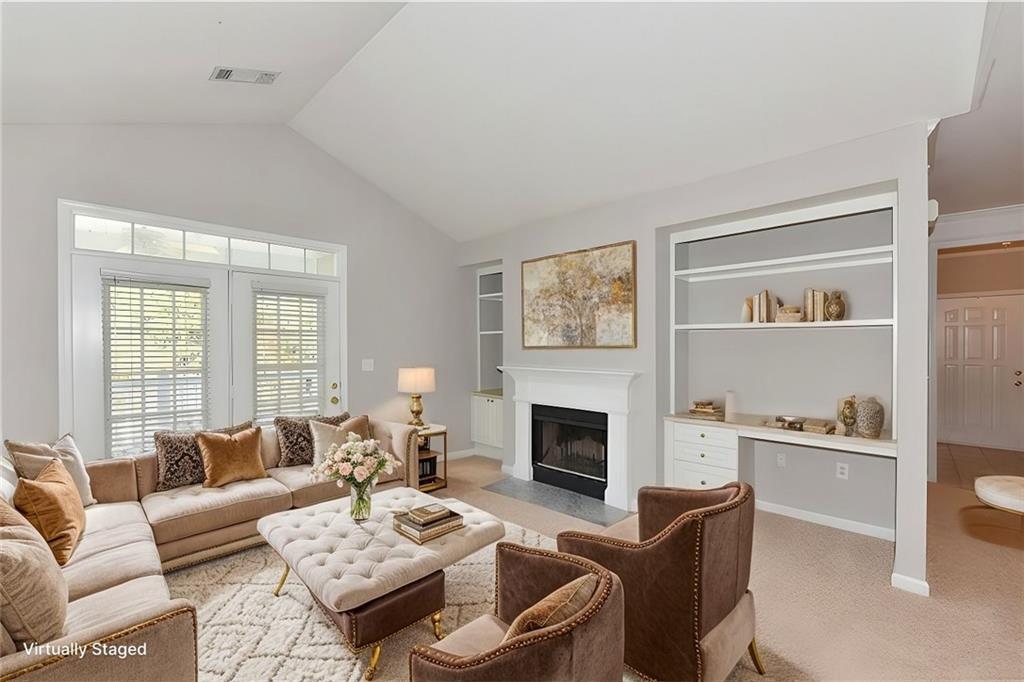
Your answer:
(409, 543), (625, 682)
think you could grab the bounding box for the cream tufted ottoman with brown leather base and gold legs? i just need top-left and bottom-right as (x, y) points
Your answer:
(256, 487), (505, 680)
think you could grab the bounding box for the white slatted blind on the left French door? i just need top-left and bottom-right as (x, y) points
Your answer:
(102, 273), (210, 456)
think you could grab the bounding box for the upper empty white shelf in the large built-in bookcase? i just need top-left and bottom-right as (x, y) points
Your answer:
(674, 244), (893, 282)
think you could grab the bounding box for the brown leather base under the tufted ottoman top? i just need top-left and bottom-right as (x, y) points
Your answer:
(313, 570), (444, 650)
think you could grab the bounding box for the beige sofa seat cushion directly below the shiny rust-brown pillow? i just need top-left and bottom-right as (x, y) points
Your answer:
(142, 478), (292, 543)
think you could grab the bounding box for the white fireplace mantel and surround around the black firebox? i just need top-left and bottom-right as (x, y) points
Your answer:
(499, 366), (638, 509)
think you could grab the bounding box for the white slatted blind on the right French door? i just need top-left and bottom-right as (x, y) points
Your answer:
(253, 289), (325, 424)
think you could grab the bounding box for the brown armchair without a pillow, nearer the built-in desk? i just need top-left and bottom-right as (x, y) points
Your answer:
(558, 483), (764, 680)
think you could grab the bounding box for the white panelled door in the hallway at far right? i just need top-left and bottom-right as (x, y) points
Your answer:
(935, 295), (1024, 450)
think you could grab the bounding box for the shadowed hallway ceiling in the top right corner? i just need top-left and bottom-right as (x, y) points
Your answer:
(929, 3), (1024, 214)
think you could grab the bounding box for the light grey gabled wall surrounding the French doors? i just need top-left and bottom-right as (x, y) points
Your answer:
(0, 125), (475, 450)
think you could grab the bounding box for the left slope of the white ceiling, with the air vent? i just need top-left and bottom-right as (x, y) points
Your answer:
(3, 2), (401, 123)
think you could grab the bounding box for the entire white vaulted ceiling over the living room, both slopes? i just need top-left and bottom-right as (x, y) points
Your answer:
(3, 3), (999, 240)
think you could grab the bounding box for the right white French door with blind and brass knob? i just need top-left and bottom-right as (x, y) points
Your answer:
(231, 272), (347, 425)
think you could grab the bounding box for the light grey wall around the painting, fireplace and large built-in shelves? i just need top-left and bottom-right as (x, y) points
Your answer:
(461, 123), (928, 591)
